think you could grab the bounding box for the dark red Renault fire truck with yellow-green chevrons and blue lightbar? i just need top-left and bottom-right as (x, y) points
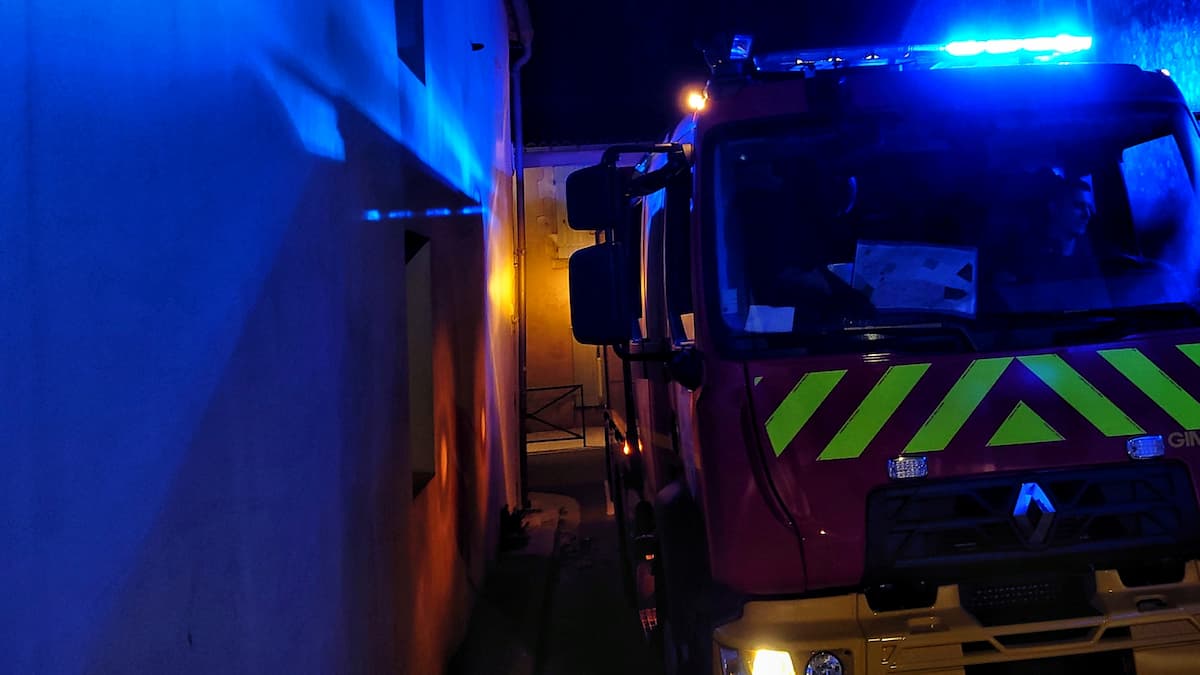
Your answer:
(566, 35), (1200, 675)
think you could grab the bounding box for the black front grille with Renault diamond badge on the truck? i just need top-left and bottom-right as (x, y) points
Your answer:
(864, 461), (1200, 590)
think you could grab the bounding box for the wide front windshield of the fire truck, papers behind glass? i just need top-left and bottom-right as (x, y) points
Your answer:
(707, 103), (1200, 351)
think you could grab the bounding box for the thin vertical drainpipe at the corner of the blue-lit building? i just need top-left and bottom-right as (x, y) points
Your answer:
(509, 0), (533, 508)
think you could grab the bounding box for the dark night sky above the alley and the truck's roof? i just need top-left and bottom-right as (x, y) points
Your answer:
(522, 0), (914, 145)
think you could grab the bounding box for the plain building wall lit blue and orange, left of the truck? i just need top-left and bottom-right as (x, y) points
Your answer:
(0, 0), (520, 674)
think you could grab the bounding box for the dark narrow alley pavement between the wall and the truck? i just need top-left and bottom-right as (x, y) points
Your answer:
(448, 449), (660, 675)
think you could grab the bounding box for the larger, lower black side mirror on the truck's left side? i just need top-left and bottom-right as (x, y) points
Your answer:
(568, 241), (634, 346)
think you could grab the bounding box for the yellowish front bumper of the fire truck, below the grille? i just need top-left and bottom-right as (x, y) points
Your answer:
(714, 561), (1200, 675)
